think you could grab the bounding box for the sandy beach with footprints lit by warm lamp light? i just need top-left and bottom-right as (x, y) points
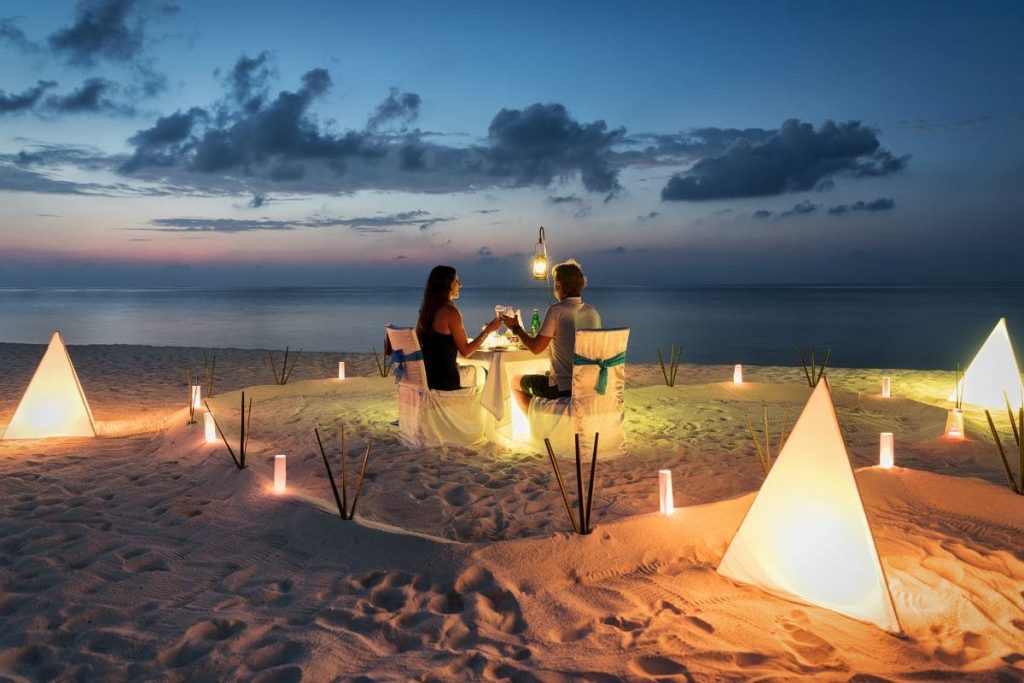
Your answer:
(0, 344), (1024, 681)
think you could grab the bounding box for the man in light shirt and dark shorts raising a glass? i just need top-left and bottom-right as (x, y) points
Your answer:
(502, 259), (601, 414)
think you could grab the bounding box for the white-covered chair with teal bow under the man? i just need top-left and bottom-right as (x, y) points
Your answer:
(529, 328), (630, 458)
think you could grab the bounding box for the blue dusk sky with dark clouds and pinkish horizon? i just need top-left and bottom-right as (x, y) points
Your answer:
(0, 0), (1024, 287)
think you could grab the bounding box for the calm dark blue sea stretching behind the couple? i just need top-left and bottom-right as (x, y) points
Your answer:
(0, 287), (1024, 370)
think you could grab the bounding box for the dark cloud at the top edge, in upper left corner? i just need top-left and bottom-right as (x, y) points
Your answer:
(48, 0), (178, 67)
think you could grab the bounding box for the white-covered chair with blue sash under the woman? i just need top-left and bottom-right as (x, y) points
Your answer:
(385, 326), (484, 449)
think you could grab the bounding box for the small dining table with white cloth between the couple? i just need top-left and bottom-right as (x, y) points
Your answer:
(462, 346), (551, 445)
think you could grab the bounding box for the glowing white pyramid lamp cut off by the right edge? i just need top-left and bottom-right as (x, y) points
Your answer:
(949, 317), (1021, 410)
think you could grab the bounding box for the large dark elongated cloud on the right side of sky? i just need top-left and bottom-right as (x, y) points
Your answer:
(662, 119), (909, 201)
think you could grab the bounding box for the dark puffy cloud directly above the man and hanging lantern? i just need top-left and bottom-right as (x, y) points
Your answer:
(481, 103), (626, 195)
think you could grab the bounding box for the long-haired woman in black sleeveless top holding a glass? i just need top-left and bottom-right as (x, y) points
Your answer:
(416, 265), (502, 391)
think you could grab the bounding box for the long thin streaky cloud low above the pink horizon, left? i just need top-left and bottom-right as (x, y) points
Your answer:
(143, 210), (452, 232)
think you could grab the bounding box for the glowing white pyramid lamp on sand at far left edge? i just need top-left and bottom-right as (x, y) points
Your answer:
(3, 332), (96, 439)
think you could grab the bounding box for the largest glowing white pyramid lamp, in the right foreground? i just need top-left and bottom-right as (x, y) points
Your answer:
(718, 378), (902, 634)
